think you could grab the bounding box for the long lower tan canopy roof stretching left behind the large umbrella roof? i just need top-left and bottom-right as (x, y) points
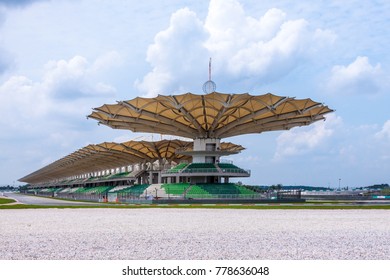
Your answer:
(19, 140), (244, 184)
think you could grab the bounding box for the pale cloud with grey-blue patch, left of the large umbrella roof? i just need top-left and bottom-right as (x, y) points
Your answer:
(0, 53), (115, 133)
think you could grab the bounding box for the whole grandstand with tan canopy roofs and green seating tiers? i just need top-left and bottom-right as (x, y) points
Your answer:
(19, 92), (332, 201)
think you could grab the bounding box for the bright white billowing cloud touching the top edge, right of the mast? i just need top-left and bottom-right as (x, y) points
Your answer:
(205, 3), (333, 82)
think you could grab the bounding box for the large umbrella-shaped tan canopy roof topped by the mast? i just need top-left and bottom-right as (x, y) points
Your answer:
(88, 92), (333, 139)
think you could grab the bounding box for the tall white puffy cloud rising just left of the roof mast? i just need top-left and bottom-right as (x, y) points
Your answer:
(136, 8), (208, 96)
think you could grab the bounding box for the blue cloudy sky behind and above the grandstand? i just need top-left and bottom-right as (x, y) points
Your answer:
(0, 0), (390, 188)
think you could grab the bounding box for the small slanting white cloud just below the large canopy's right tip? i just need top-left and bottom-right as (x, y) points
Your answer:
(274, 114), (341, 160)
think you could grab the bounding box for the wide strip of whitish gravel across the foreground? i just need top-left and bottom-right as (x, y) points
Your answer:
(0, 208), (390, 260)
